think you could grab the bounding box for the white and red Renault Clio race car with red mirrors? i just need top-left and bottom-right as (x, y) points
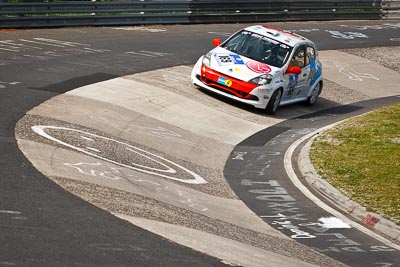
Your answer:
(191, 25), (323, 114)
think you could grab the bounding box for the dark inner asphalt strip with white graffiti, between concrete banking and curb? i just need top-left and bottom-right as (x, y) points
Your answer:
(224, 96), (400, 266)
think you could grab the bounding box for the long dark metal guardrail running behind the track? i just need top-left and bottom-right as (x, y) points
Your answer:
(0, 0), (394, 28)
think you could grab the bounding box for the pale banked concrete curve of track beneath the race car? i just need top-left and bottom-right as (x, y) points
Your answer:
(15, 48), (400, 266)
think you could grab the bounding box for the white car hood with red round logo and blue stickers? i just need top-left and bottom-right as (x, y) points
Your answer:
(210, 47), (280, 81)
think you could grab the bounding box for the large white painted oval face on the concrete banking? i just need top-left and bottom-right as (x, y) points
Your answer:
(32, 125), (207, 184)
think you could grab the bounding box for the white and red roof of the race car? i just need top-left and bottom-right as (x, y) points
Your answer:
(245, 25), (313, 47)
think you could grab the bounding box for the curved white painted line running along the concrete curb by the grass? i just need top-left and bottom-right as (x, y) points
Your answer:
(284, 122), (400, 250)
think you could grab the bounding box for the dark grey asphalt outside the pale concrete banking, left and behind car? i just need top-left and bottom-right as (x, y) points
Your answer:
(0, 21), (400, 266)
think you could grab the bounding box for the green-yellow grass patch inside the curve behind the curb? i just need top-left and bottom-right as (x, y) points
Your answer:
(310, 104), (400, 225)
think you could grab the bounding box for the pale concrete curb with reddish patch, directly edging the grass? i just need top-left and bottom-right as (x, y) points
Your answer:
(297, 123), (400, 244)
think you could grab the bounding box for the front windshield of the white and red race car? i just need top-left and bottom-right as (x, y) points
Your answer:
(221, 30), (292, 68)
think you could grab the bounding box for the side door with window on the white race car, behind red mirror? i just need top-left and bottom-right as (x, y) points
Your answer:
(284, 45), (310, 100)
